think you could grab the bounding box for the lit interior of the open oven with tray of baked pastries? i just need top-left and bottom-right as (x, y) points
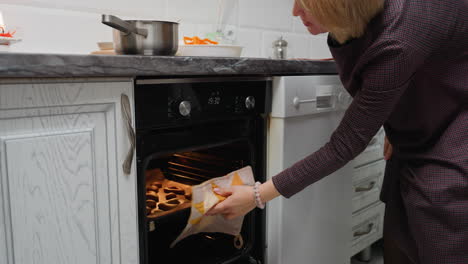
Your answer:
(145, 141), (255, 263)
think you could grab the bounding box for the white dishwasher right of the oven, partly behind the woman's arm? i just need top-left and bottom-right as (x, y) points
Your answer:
(267, 76), (352, 264)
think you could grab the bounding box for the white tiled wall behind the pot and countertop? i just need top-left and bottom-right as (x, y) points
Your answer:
(0, 0), (331, 58)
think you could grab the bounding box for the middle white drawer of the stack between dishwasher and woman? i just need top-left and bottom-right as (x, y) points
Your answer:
(352, 160), (385, 212)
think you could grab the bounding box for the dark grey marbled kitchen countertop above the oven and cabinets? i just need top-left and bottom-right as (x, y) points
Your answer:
(0, 52), (337, 78)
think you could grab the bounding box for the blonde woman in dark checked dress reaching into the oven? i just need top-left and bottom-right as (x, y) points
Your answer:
(209, 0), (468, 264)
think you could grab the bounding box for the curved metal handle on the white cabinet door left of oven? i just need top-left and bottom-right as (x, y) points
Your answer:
(120, 94), (136, 175)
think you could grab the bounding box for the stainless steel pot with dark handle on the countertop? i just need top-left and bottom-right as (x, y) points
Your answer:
(102, 15), (179, 56)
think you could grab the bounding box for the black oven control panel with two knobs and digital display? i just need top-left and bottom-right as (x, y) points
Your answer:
(135, 78), (271, 127)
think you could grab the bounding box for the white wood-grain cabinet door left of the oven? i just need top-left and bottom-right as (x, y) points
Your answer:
(0, 80), (138, 264)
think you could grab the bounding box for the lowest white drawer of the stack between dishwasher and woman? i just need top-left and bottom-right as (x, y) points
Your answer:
(351, 202), (385, 256)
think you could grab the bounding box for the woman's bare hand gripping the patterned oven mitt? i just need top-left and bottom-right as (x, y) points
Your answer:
(206, 186), (256, 220)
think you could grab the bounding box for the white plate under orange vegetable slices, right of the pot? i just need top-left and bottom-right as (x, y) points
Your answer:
(176, 45), (243, 57)
